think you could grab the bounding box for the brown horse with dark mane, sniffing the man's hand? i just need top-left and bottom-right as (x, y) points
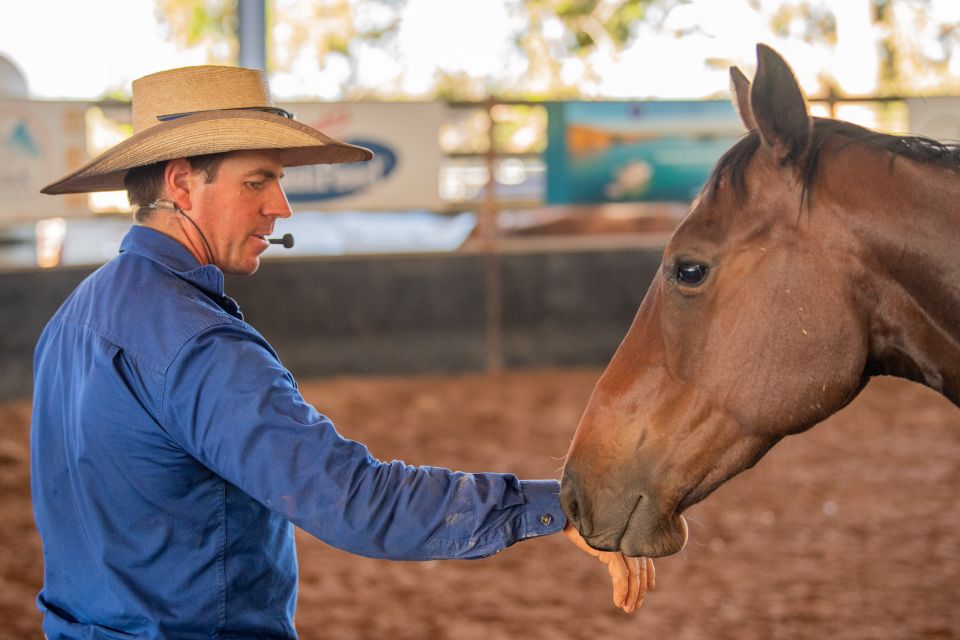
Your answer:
(561, 45), (960, 556)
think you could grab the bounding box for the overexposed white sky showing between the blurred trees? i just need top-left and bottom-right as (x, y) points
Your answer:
(0, 0), (960, 99)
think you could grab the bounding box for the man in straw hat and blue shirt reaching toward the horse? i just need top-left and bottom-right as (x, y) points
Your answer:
(31, 66), (653, 638)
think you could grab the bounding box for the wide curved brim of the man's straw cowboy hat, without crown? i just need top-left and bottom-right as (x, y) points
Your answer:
(40, 109), (373, 195)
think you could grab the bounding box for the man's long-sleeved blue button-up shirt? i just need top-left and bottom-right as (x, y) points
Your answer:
(31, 226), (566, 639)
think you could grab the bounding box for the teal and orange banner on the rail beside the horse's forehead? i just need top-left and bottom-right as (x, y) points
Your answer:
(546, 100), (745, 204)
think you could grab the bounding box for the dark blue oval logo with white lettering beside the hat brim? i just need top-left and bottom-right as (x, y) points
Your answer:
(283, 140), (397, 202)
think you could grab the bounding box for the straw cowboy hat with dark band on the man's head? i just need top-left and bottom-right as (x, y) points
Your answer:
(41, 66), (373, 194)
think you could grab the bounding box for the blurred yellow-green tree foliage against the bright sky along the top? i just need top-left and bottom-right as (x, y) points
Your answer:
(157, 0), (960, 100)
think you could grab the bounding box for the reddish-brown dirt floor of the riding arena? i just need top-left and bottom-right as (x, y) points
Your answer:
(0, 370), (960, 640)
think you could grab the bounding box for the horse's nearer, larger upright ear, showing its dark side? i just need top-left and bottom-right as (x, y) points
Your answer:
(750, 44), (813, 163)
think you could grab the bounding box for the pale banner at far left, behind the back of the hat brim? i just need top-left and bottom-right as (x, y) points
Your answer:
(0, 100), (89, 222)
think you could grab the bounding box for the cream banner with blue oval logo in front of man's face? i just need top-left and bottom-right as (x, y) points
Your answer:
(281, 102), (444, 211)
